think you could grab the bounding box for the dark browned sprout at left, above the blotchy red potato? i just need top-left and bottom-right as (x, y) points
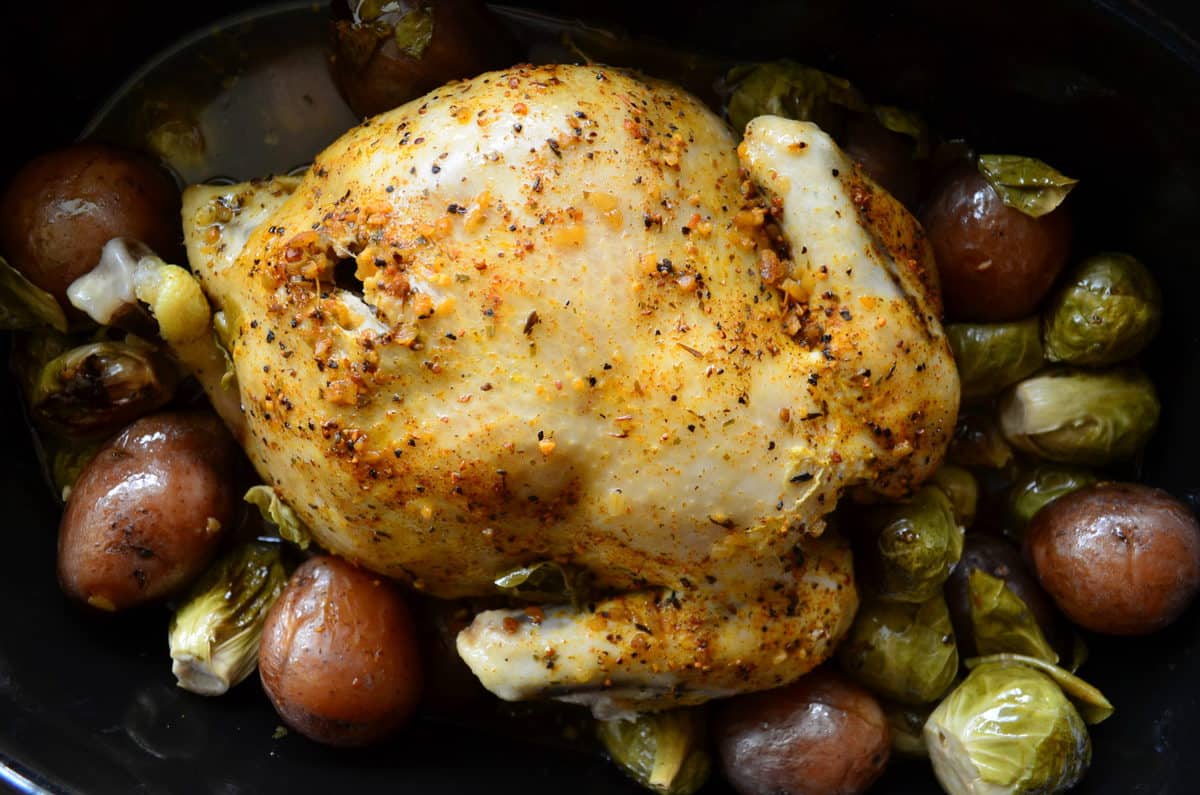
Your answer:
(29, 342), (178, 434)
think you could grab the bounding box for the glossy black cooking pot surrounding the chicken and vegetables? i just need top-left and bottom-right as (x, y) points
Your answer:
(0, 0), (1200, 795)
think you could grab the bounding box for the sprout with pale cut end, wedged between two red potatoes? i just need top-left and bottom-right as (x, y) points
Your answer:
(168, 542), (288, 695)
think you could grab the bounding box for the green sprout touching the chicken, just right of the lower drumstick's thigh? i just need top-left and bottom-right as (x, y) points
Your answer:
(866, 486), (962, 602)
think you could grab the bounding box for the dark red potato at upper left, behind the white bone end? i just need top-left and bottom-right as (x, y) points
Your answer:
(0, 143), (184, 307)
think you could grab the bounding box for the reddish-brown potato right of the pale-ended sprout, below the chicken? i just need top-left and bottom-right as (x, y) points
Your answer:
(258, 556), (421, 747)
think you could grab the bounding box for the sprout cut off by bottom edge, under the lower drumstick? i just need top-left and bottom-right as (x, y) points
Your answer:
(596, 710), (712, 795)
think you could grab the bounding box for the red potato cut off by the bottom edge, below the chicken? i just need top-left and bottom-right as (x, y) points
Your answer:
(715, 668), (890, 795)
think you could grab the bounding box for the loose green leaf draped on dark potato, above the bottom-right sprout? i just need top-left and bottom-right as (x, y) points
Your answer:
(967, 569), (1058, 663)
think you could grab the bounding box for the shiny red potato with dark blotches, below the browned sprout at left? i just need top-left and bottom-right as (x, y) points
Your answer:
(58, 412), (238, 610)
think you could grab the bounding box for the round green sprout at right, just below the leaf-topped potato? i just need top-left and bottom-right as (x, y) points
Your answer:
(1043, 253), (1163, 366)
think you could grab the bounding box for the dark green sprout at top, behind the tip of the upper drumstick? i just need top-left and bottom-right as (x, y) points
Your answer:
(727, 61), (870, 135)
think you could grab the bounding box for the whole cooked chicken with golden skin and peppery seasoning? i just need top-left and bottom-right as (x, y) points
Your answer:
(177, 66), (958, 715)
